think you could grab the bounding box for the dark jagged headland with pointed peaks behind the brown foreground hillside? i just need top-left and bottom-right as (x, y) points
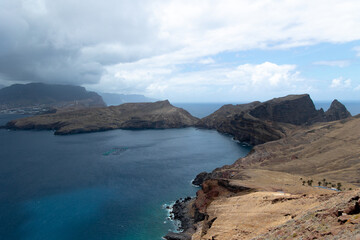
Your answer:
(197, 94), (351, 145)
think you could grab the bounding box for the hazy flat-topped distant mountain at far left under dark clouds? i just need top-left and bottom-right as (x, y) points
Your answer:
(0, 83), (106, 114)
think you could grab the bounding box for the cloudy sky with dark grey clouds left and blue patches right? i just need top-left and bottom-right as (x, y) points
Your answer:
(0, 0), (360, 102)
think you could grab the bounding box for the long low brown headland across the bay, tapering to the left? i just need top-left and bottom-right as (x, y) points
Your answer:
(7, 101), (198, 134)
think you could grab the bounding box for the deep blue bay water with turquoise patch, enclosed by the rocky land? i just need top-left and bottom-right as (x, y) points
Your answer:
(0, 116), (250, 240)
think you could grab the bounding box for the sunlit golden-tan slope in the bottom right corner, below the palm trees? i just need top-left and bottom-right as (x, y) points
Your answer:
(192, 188), (360, 240)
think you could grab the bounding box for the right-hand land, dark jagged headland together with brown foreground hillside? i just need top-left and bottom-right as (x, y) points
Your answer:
(167, 94), (360, 240)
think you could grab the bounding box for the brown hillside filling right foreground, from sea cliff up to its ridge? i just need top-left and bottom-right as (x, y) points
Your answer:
(186, 116), (360, 240)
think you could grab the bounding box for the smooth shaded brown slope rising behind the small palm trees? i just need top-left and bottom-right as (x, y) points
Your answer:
(213, 116), (360, 186)
